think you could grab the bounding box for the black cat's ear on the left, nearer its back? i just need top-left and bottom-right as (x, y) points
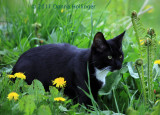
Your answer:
(92, 32), (107, 52)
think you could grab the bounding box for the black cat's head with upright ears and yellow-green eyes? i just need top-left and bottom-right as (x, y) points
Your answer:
(91, 31), (125, 71)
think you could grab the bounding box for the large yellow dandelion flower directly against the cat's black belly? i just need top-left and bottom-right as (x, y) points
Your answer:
(52, 77), (66, 88)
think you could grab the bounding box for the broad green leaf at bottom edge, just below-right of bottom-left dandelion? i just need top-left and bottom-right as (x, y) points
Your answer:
(19, 95), (36, 115)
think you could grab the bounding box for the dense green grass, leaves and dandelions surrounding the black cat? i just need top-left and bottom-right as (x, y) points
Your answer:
(0, 0), (160, 115)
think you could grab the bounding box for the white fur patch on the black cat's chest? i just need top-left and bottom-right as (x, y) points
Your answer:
(95, 68), (109, 87)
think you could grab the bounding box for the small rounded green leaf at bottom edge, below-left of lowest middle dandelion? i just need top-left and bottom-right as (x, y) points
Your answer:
(38, 105), (52, 115)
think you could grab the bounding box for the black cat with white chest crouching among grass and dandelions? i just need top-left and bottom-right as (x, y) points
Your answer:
(13, 32), (125, 105)
